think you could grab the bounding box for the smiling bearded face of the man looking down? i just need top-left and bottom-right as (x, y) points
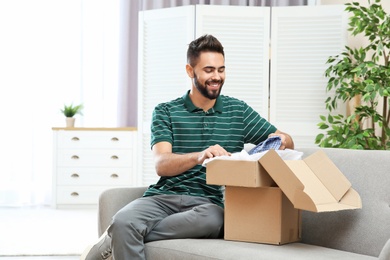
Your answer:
(193, 52), (225, 99)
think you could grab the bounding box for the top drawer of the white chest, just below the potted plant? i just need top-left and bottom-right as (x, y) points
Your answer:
(58, 131), (136, 148)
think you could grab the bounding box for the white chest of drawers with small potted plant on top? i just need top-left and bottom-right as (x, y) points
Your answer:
(52, 128), (137, 207)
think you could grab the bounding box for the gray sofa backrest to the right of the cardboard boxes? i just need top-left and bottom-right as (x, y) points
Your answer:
(302, 148), (390, 257)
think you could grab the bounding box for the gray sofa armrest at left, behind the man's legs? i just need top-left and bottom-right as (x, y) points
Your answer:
(98, 187), (146, 237)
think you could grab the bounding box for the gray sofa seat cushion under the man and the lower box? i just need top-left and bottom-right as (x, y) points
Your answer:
(145, 239), (377, 260)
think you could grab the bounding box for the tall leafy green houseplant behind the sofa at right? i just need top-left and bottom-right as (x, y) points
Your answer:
(315, 0), (390, 150)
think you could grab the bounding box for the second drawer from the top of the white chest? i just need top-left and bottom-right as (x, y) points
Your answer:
(57, 149), (133, 167)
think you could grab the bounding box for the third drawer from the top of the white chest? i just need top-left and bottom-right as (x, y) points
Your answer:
(57, 168), (132, 186)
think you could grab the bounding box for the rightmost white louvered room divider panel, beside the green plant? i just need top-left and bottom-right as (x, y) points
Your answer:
(270, 5), (347, 147)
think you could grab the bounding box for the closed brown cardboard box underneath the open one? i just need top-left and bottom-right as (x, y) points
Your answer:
(224, 186), (301, 245)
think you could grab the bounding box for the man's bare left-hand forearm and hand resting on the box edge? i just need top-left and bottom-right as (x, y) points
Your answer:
(152, 142), (230, 176)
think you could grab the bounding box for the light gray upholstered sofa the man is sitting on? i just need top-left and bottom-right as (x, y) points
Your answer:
(98, 148), (390, 260)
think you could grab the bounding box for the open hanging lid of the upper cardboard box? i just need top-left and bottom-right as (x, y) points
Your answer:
(259, 150), (361, 212)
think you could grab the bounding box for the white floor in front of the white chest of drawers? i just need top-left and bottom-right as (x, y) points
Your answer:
(0, 207), (98, 260)
